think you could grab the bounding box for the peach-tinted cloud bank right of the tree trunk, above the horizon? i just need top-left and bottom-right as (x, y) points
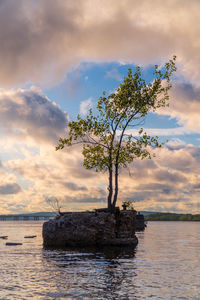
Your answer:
(115, 145), (200, 213)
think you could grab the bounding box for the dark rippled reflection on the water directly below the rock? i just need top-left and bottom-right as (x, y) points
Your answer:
(43, 248), (137, 299)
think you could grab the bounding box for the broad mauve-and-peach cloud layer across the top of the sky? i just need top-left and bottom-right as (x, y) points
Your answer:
(0, 0), (200, 86)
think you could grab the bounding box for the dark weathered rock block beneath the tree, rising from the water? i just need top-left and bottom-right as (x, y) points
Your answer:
(43, 211), (137, 247)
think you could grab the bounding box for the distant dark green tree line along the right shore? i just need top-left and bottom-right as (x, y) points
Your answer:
(145, 213), (200, 221)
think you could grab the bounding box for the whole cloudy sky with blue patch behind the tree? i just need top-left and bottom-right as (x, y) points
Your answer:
(0, 0), (200, 214)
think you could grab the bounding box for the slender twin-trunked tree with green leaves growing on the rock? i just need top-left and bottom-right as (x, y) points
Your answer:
(56, 56), (176, 210)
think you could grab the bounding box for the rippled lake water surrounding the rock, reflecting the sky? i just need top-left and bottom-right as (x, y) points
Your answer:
(0, 221), (200, 300)
